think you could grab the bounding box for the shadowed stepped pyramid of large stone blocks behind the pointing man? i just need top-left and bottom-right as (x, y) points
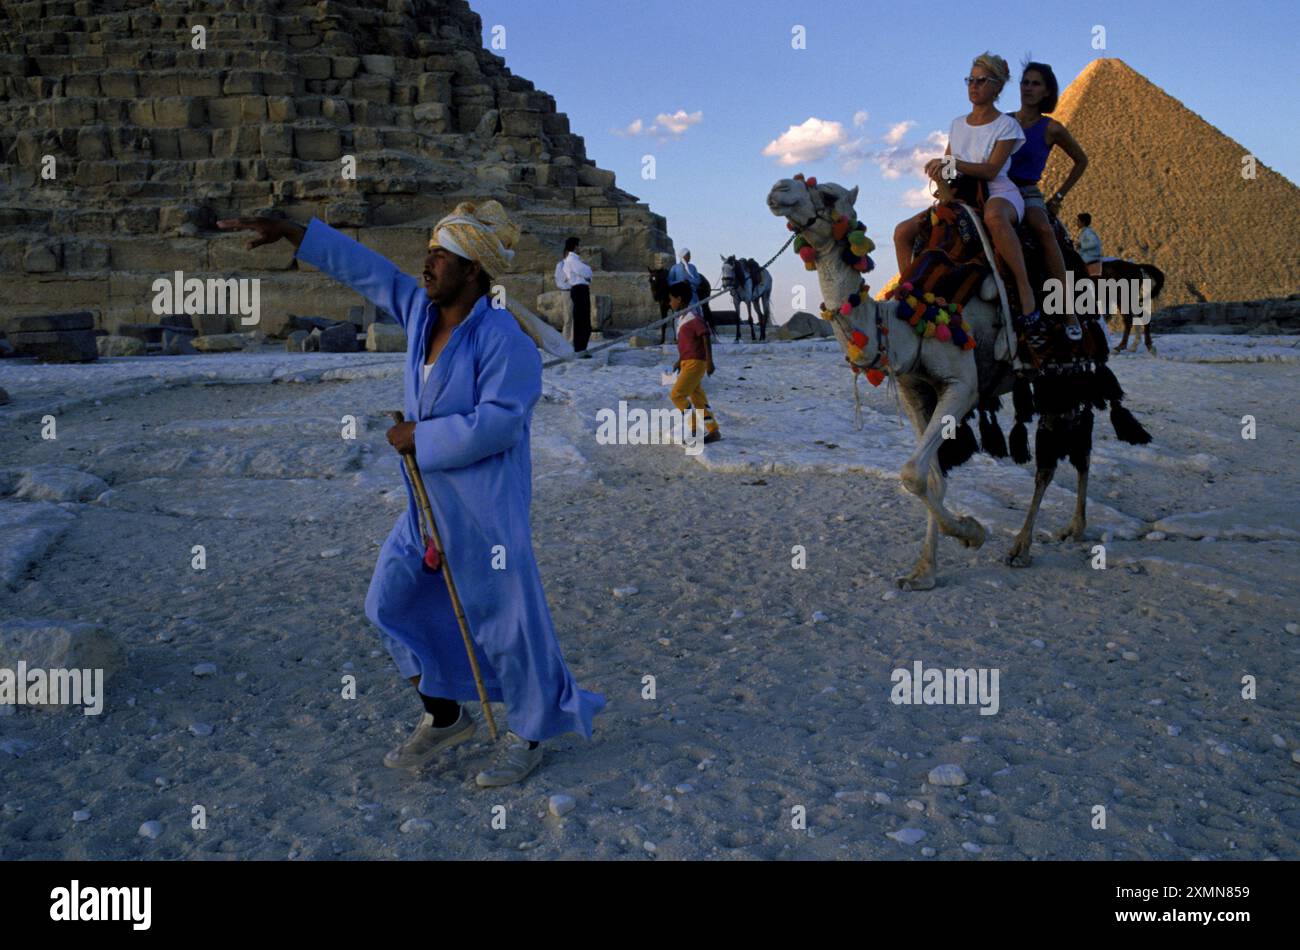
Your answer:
(0, 0), (672, 335)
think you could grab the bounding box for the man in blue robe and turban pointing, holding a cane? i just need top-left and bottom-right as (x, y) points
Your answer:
(218, 201), (605, 788)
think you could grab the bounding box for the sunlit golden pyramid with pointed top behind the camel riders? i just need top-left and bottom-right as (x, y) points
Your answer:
(1044, 58), (1300, 305)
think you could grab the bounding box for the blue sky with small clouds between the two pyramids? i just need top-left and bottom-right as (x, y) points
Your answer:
(471, 0), (1300, 322)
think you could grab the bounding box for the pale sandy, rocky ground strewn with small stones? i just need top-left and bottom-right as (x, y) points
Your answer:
(0, 337), (1300, 860)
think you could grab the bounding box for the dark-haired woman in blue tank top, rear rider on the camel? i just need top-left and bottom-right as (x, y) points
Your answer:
(1006, 62), (1088, 339)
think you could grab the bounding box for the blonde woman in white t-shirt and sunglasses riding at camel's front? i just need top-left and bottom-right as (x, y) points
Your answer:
(894, 53), (1039, 324)
